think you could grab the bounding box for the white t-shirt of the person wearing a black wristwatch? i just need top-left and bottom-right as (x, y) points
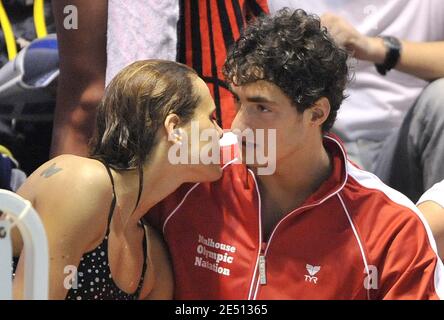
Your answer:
(269, 0), (444, 141)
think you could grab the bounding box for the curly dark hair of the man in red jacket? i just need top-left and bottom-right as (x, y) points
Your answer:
(223, 8), (348, 132)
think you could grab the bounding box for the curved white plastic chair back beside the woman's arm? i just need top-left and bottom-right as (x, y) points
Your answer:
(0, 189), (49, 300)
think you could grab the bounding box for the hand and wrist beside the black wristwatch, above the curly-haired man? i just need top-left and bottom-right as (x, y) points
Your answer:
(321, 13), (386, 64)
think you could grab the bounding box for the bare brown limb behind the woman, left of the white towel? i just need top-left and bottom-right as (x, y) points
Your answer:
(51, 0), (108, 157)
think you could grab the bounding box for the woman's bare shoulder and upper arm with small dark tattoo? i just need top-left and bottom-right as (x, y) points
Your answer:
(14, 157), (112, 299)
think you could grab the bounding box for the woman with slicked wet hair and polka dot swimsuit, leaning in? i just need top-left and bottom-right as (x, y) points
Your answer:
(14, 60), (222, 300)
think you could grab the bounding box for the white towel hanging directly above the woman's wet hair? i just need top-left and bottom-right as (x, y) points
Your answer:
(106, 0), (179, 85)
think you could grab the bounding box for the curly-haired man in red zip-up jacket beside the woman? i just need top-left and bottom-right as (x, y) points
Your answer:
(147, 10), (444, 299)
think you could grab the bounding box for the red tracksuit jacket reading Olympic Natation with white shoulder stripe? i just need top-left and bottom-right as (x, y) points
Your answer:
(147, 137), (444, 299)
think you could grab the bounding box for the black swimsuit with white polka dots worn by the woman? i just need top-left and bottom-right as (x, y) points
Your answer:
(66, 165), (147, 300)
